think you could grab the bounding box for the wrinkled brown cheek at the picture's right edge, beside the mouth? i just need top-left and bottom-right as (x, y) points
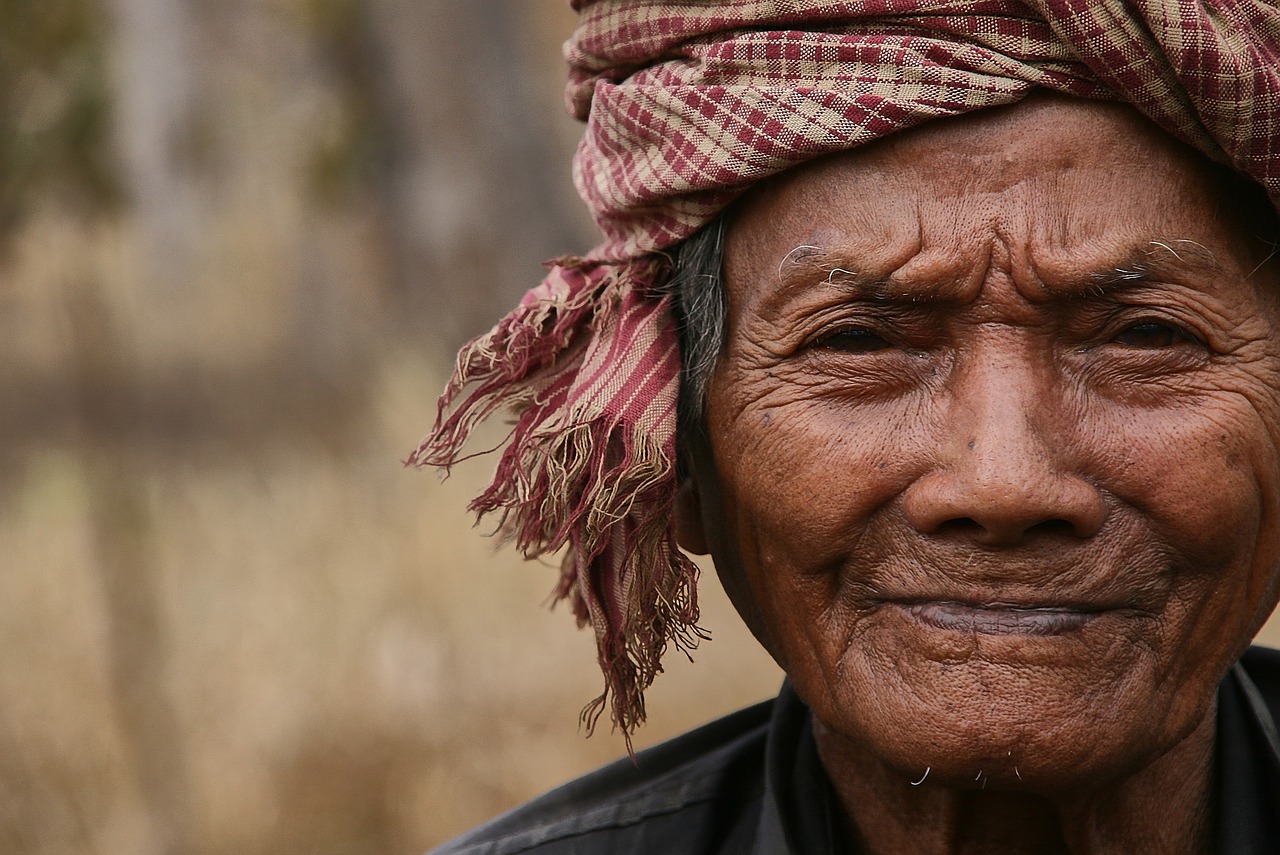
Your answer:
(1091, 393), (1280, 680)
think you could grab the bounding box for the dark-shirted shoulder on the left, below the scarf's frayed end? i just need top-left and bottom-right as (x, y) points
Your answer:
(430, 701), (774, 855)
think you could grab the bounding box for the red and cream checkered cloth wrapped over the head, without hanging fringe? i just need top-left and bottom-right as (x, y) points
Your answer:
(566, 0), (1280, 261)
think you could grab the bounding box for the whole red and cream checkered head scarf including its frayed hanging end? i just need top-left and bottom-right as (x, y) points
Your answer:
(410, 0), (1280, 736)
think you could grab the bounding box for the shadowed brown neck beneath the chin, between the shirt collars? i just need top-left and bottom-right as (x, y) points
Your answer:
(814, 713), (1216, 855)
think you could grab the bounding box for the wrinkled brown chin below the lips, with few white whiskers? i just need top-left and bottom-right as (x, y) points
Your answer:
(797, 621), (1221, 794)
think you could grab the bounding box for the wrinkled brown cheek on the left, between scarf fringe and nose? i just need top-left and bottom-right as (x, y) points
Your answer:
(708, 386), (928, 677)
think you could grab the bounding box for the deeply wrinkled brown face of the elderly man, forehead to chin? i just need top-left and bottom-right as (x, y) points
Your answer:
(677, 99), (1280, 787)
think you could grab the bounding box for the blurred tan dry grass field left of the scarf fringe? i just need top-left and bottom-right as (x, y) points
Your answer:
(0, 203), (778, 855)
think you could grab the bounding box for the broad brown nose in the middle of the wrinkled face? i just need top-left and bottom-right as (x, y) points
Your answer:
(904, 348), (1107, 547)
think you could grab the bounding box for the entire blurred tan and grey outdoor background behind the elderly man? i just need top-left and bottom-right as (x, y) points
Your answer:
(0, 0), (1280, 855)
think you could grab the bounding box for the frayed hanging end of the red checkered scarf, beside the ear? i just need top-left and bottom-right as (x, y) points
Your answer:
(406, 259), (708, 753)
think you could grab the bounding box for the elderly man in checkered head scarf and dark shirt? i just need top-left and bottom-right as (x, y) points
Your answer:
(415, 0), (1280, 855)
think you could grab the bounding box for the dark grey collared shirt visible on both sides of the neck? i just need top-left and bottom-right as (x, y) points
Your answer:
(431, 648), (1280, 855)
